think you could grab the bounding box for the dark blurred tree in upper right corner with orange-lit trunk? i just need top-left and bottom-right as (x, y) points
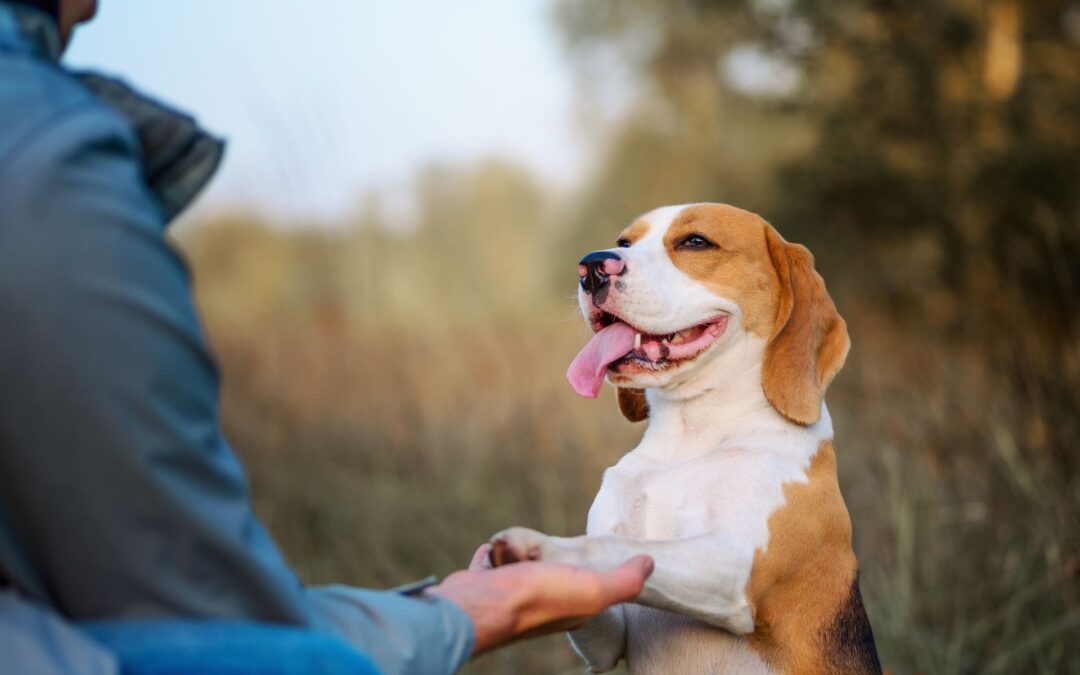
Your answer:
(775, 0), (1080, 326)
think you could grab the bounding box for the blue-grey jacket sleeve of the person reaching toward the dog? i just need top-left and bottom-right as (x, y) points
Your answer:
(0, 104), (473, 673)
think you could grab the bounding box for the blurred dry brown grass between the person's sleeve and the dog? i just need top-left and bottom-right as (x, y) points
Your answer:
(206, 319), (640, 673)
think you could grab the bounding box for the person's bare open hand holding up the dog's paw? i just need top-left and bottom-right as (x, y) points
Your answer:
(426, 544), (652, 653)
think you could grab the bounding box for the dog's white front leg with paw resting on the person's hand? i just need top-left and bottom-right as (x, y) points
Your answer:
(491, 527), (754, 634)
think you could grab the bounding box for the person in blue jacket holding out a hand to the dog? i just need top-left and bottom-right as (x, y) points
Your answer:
(0, 0), (651, 673)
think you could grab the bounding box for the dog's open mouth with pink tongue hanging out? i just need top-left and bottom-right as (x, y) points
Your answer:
(566, 312), (728, 399)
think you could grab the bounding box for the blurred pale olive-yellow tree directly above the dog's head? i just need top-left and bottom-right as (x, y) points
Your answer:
(555, 0), (812, 255)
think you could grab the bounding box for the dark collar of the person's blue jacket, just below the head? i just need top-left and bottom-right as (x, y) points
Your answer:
(0, 0), (225, 219)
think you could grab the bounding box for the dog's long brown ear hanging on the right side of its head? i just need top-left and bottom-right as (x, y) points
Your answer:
(761, 227), (851, 424)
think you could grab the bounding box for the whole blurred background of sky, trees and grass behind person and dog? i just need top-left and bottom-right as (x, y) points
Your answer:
(67, 0), (1080, 674)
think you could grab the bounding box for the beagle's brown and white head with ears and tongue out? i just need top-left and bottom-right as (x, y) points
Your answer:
(567, 204), (850, 424)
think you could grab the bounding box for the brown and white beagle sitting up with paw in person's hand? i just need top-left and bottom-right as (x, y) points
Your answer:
(490, 204), (880, 674)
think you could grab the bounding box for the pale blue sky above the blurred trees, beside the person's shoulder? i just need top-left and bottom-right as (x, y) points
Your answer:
(65, 0), (583, 219)
